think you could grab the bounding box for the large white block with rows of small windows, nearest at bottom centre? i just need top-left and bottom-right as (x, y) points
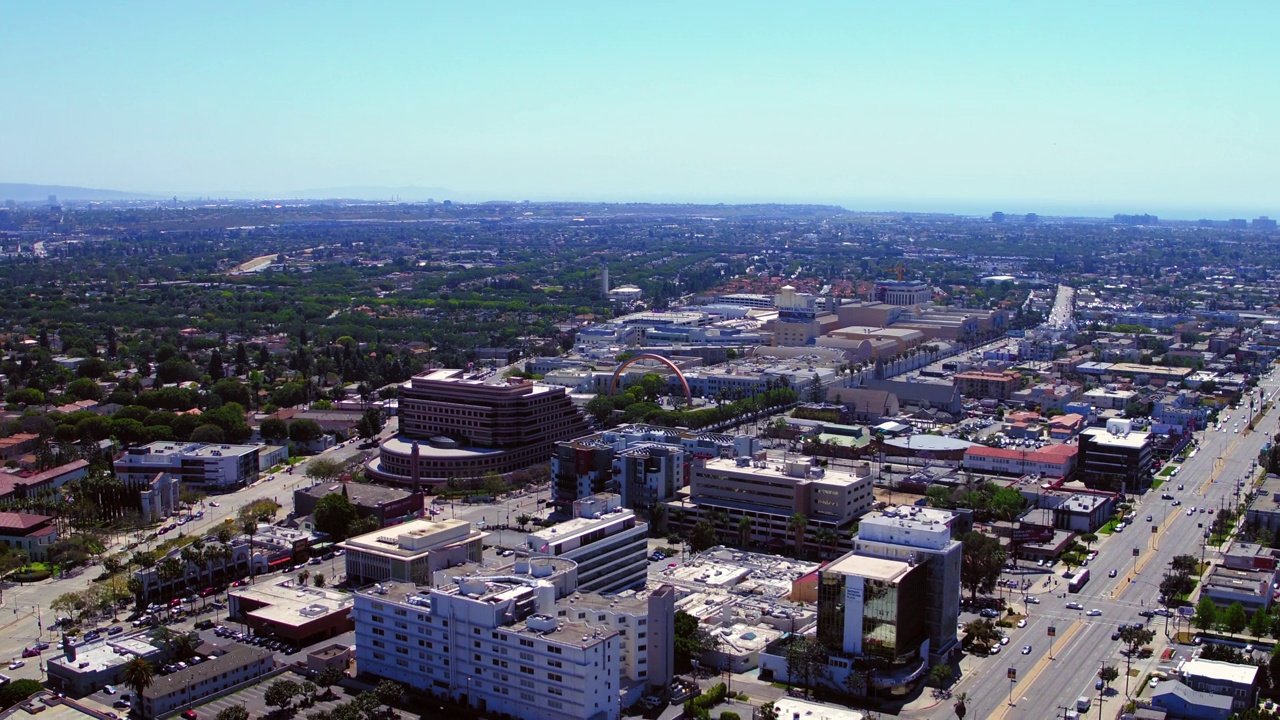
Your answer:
(352, 577), (622, 720)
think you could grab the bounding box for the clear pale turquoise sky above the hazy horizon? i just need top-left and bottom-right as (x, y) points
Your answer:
(0, 0), (1280, 218)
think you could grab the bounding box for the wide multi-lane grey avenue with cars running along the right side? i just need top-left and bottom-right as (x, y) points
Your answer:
(928, 366), (1280, 720)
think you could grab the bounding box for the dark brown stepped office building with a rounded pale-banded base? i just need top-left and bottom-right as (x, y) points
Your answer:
(366, 370), (588, 489)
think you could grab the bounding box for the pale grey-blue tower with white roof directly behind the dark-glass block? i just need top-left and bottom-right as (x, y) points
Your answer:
(854, 507), (963, 664)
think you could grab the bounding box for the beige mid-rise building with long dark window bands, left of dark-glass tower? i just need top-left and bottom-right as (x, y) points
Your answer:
(664, 457), (874, 550)
